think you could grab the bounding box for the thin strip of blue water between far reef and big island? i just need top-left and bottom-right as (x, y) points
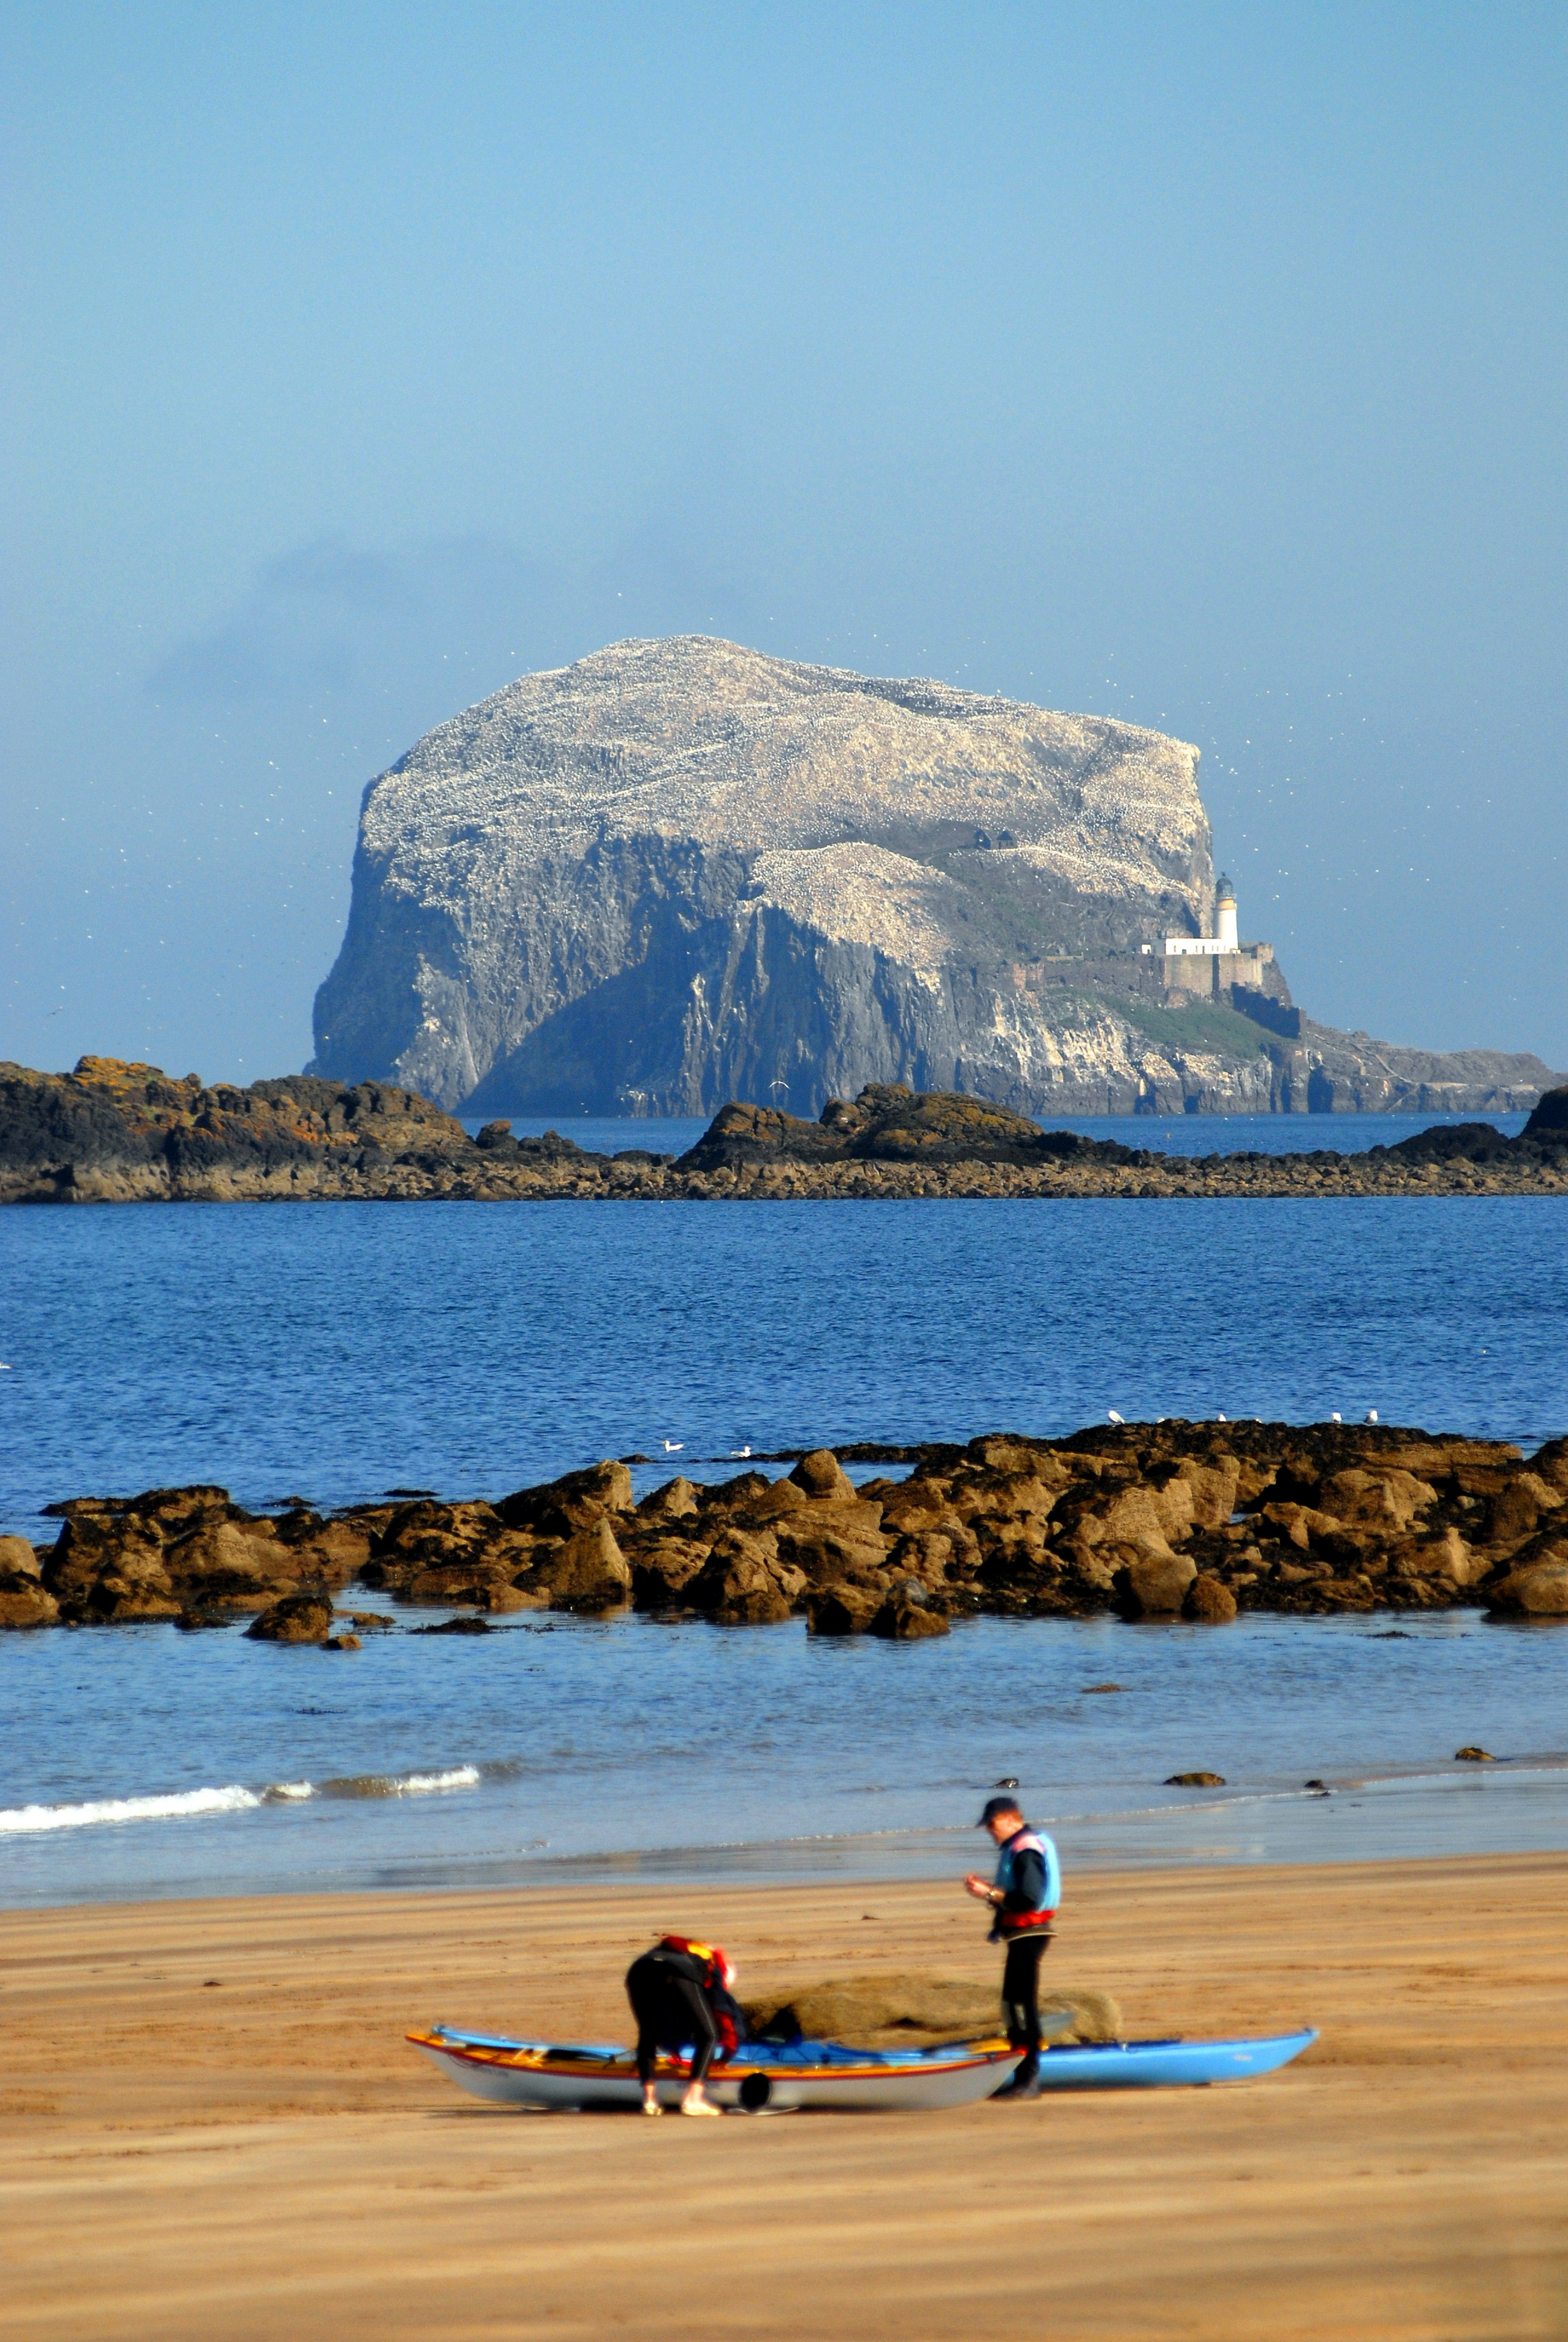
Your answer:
(459, 1115), (1530, 1155)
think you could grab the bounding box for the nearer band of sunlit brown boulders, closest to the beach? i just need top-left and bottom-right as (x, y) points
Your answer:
(0, 1422), (1568, 1646)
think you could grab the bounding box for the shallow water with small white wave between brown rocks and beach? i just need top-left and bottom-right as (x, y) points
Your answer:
(0, 1616), (1568, 1904)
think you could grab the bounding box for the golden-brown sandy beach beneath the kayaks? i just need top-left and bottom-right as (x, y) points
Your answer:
(0, 1855), (1568, 2342)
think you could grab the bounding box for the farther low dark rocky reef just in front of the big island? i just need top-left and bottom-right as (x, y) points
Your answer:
(0, 1056), (1568, 1204)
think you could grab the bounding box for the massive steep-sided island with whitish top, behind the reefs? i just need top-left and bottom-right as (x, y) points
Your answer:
(310, 634), (1554, 1115)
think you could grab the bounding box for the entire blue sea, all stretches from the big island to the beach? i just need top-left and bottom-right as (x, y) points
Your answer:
(0, 1117), (1568, 1909)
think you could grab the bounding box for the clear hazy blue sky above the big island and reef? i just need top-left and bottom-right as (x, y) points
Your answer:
(0, 0), (1568, 1080)
